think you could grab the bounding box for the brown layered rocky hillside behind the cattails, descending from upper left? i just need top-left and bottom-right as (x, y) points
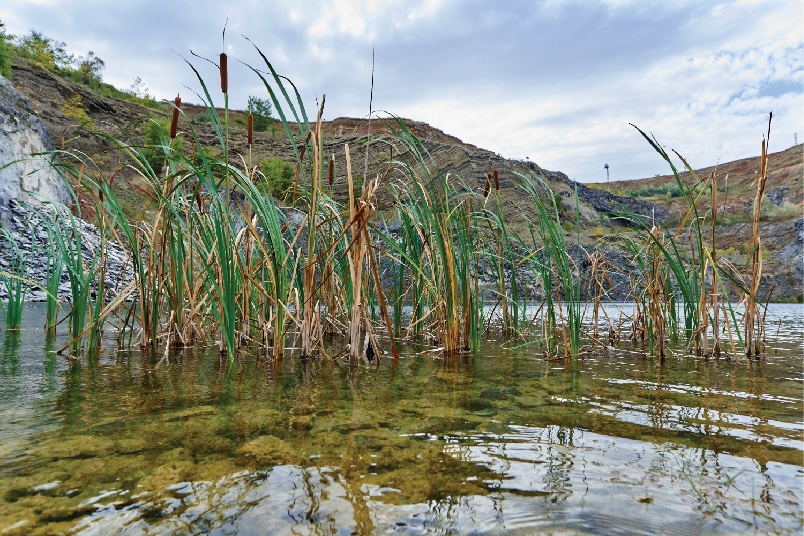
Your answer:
(4, 56), (653, 226)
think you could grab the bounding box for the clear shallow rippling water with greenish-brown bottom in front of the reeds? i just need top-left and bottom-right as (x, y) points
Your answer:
(0, 305), (804, 535)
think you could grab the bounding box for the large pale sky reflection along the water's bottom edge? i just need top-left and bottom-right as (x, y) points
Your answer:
(70, 426), (802, 534)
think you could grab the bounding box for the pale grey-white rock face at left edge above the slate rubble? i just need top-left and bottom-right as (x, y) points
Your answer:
(0, 77), (69, 225)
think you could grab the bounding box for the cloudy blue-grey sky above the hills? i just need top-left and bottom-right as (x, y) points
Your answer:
(0, 0), (804, 181)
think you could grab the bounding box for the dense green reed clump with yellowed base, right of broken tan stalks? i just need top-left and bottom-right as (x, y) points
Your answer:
(384, 119), (480, 355)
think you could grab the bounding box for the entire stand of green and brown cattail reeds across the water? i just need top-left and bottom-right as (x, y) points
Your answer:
(17, 31), (767, 372)
